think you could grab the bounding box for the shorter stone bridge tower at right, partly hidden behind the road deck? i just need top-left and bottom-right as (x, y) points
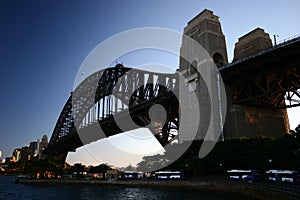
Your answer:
(225, 28), (289, 138)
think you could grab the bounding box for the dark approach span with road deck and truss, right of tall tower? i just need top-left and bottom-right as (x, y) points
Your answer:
(220, 36), (300, 109)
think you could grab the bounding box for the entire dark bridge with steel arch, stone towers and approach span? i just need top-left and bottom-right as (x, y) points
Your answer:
(48, 10), (300, 160)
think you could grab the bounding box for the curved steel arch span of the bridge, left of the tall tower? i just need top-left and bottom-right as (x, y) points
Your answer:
(48, 64), (179, 158)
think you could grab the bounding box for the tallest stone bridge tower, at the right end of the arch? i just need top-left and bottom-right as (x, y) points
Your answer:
(179, 9), (228, 140)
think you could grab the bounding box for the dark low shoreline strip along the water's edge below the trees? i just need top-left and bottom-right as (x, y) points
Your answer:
(18, 179), (292, 200)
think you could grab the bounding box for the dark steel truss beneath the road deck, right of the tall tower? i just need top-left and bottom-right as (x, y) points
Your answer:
(233, 66), (300, 109)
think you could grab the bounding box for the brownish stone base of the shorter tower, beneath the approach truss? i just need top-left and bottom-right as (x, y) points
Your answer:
(225, 104), (289, 138)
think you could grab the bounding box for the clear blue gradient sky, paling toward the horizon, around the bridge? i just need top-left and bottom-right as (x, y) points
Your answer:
(0, 0), (300, 166)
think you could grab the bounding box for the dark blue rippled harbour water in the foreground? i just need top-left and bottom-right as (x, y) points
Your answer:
(0, 176), (253, 200)
